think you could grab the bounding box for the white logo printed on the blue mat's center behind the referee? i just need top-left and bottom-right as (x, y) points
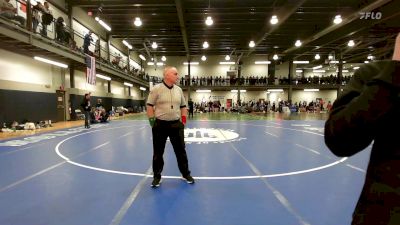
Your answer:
(185, 128), (246, 144)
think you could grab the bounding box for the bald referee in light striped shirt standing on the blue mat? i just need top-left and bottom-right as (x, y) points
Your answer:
(147, 66), (194, 188)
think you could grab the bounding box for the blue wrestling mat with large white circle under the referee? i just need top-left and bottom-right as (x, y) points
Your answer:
(0, 120), (370, 225)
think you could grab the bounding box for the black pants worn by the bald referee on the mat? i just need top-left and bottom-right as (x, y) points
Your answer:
(152, 119), (190, 178)
